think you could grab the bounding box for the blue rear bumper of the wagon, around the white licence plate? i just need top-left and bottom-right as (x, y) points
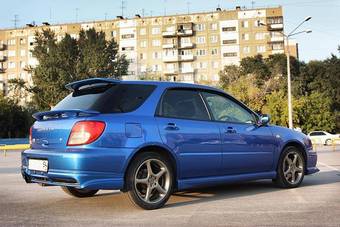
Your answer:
(21, 148), (132, 189)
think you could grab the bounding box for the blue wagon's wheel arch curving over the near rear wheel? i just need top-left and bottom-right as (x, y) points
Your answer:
(122, 143), (179, 191)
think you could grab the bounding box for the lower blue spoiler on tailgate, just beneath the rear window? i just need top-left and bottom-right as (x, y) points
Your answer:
(32, 109), (100, 121)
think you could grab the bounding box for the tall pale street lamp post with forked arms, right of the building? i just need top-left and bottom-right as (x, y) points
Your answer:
(260, 17), (312, 129)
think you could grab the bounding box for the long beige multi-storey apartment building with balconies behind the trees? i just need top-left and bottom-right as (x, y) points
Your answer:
(0, 7), (294, 96)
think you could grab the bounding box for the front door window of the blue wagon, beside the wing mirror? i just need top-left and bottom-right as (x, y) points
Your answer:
(202, 92), (255, 124)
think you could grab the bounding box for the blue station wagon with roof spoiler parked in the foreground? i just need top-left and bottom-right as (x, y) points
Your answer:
(21, 78), (318, 209)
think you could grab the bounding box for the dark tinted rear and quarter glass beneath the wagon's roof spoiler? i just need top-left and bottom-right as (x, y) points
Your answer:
(53, 83), (156, 113)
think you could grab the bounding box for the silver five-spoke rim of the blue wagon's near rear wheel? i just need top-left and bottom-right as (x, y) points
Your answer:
(134, 159), (170, 203)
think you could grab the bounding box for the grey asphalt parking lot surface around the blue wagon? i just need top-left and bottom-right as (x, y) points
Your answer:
(0, 146), (340, 226)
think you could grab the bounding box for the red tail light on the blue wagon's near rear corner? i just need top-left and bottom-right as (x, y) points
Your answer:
(67, 121), (105, 146)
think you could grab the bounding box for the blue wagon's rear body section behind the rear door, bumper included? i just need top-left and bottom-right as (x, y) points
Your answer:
(22, 81), (160, 189)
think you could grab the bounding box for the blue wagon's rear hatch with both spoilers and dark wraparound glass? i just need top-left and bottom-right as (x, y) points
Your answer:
(31, 78), (154, 149)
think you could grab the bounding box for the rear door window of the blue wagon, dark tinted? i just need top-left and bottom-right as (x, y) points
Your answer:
(158, 89), (210, 120)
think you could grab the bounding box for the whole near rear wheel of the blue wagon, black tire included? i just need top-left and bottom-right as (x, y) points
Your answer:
(125, 152), (174, 210)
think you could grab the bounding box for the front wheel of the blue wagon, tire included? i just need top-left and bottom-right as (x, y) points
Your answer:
(273, 146), (306, 188)
